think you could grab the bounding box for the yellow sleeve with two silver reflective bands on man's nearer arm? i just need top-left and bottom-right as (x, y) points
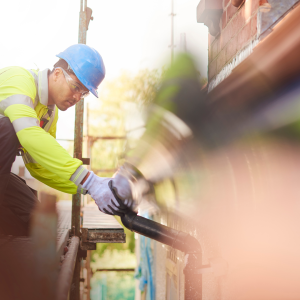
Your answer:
(0, 70), (88, 190)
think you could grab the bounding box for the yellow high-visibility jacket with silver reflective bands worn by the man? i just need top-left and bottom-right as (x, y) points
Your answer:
(0, 67), (88, 194)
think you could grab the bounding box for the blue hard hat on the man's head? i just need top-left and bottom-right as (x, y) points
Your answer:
(56, 44), (105, 98)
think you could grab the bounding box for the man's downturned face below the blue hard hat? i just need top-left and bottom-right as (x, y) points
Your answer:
(51, 68), (88, 111)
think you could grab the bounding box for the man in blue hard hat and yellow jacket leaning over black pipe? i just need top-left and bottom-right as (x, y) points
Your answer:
(0, 44), (130, 235)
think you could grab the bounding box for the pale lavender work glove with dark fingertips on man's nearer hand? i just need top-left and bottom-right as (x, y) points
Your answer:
(82, 171), (127, 216)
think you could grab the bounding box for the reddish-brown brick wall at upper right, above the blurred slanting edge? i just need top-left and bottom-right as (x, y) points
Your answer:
(208, 0), (266, 81)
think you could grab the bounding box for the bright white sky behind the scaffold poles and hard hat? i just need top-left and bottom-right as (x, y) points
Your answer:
(0, 0), (208, 138)
